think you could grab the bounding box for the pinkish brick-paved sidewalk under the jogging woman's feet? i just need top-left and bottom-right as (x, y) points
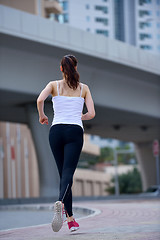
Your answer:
(0, 199), (160, 240)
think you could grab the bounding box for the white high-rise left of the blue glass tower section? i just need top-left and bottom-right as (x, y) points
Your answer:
(50, 0), (114, 38)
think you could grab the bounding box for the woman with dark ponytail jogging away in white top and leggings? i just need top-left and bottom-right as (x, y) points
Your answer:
(37, 55), (95, 232)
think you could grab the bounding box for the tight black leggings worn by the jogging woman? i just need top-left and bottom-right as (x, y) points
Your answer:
(49, 124), (83, 217)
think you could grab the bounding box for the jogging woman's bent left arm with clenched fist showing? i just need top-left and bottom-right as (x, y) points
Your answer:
(37, 82), (53, 125)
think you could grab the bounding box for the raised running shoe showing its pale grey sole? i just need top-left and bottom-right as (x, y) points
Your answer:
(52, 201), (63, 232)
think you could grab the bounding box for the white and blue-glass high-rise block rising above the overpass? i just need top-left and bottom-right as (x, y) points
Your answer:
(48, 0), (160, 54)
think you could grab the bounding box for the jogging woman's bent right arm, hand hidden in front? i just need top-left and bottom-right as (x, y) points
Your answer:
(81, 85), (96, 120)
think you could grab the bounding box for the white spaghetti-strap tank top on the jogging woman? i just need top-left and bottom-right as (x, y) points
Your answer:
(51, 81), (84, 131)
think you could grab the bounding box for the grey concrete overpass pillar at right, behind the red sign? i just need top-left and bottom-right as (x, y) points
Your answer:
(135, 142), (156, 191)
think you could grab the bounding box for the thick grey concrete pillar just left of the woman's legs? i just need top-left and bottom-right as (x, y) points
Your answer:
(26, 104), (59, 198)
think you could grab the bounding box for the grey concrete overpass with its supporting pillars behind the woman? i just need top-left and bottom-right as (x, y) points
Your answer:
(0, 5), (160, 196)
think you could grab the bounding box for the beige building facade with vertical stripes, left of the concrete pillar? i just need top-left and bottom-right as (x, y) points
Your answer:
(0, 122), (40, 199)
